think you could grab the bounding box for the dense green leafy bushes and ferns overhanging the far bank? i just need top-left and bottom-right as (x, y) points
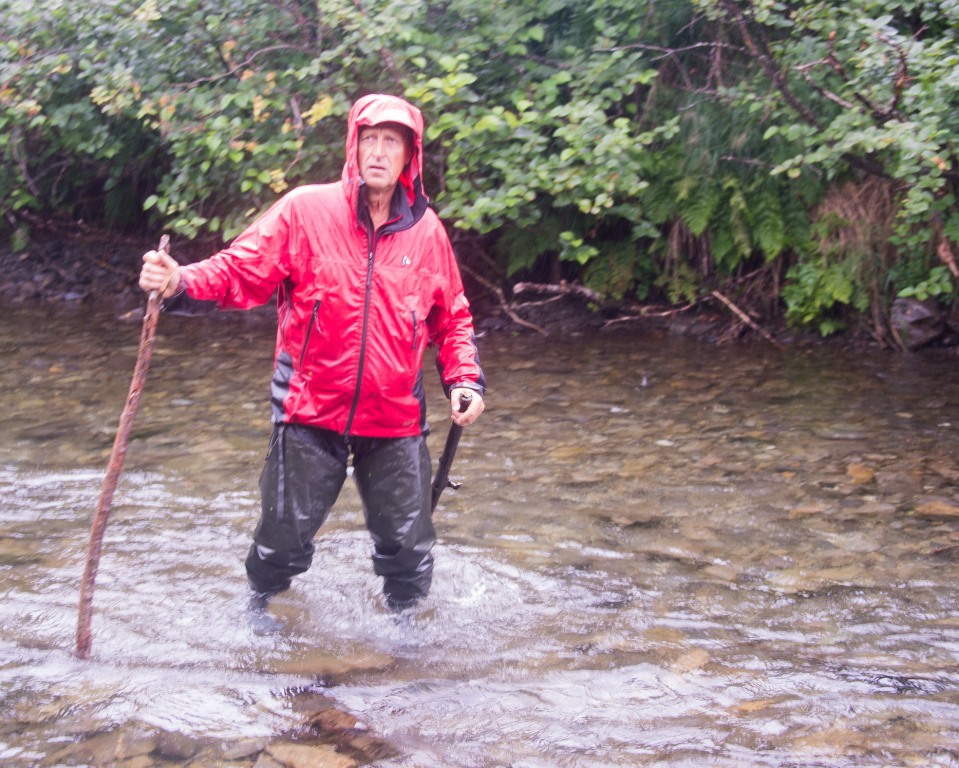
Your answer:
(0, 0), (959, 340)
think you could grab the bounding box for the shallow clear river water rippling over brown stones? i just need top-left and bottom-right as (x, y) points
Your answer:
(0, 306), (959, 768)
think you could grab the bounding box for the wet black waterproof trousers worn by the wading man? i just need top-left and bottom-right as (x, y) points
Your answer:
(246, 424), (436, 609)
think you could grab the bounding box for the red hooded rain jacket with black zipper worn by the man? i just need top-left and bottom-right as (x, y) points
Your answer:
(166, 95), (486, 437)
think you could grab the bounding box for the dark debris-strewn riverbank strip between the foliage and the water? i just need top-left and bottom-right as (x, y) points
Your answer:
(0, 228), (957, 348)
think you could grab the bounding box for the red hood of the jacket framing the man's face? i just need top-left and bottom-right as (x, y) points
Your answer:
(341, 93), (429, 219)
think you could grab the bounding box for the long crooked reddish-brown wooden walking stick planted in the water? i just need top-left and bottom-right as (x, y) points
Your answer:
(77, 235), (170, 659)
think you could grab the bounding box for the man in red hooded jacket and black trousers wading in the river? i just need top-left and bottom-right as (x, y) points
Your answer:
(140, 95), (486, 610)
